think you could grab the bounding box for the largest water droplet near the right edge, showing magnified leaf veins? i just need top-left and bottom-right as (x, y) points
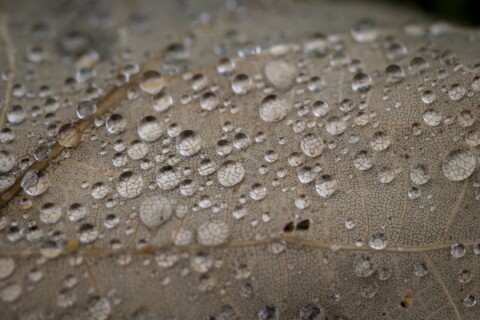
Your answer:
(442, 149), (477, 181)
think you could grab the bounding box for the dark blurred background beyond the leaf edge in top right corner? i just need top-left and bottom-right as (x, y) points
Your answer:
(402, 0), (480, 26)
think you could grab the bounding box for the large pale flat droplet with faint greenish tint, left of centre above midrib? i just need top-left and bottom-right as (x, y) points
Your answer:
(140, 195), (172, 229)
